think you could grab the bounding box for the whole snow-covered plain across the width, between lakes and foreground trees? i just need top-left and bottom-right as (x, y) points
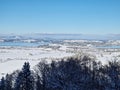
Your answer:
(0, 40), (120, 78)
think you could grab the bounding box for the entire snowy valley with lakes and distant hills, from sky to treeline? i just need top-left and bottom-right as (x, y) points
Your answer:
(0, 35), (120, 77)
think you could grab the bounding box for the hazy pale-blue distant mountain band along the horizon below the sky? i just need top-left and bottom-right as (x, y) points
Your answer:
(0, 33), (120, 40)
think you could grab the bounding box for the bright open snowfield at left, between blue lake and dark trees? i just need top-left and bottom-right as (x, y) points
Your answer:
(0, 47), (73, 77)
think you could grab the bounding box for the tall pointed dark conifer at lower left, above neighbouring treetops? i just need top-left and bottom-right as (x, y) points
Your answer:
(15, 62), (34, 90)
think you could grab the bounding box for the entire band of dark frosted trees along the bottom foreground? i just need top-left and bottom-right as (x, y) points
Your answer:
(0, 56), (120, 90)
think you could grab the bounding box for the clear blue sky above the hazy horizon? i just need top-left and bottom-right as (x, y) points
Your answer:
(0, 0), (120, 34)
